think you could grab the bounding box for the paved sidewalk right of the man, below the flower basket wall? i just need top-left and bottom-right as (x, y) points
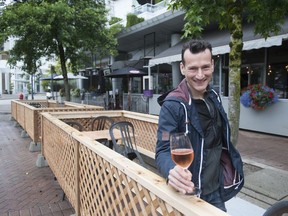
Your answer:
(237, 130), (288, 212)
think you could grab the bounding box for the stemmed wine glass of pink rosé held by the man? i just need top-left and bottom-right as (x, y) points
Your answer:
(170, 132), (200, 196)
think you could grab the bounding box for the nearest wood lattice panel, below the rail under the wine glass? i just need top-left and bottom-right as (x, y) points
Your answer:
(79, 146), (181, 215)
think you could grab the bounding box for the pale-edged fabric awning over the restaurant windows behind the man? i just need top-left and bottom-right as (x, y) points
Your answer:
(149, 32), (288, 67)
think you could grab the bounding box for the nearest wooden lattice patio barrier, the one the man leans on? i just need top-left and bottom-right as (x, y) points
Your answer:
(41, 111), (227, 216)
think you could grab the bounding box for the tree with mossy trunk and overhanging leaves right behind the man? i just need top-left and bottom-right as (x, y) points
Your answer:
(169, 0), (288, 145)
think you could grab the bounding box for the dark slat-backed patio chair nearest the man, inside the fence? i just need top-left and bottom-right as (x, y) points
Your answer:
(109, 121), (146, 167)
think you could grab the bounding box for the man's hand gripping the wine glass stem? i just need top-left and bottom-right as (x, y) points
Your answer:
(168, 165), (194, 194)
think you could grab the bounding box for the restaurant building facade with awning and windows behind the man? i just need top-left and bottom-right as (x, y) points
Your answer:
(108, 1), (288, 136)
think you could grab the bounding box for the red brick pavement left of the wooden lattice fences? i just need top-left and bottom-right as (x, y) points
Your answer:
(0, 110), (74, 216)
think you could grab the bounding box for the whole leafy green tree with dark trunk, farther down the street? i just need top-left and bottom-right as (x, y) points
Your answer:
(0, 0), (117, 101)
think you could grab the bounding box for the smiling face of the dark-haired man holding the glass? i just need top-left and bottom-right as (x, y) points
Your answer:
(180, 49), (214, 98)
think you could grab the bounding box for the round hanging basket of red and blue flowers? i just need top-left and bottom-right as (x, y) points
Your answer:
(240, 84), (279, 110)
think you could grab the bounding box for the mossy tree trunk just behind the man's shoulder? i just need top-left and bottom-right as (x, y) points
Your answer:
(228, 4), (243, 146)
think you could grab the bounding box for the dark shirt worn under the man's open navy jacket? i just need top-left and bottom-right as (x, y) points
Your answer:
(193, 97), (222, 195)
